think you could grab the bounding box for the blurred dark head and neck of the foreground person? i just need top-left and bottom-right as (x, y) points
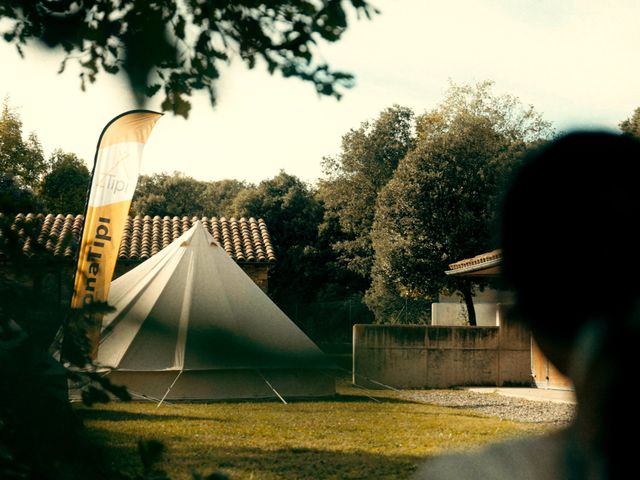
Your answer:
(501, 132), (640, 479)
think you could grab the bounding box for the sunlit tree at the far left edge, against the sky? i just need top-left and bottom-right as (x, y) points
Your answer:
(0, 98), (47, 188)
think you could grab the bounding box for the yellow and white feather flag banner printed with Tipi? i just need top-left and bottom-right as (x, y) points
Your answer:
(71, 110), (162, 357)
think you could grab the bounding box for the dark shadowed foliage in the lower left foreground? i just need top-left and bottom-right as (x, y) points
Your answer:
(0, 215), (130, 480)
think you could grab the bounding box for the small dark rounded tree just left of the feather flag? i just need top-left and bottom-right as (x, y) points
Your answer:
(39, 149), (91, 214)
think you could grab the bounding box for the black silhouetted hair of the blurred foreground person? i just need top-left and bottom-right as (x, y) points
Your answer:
(501, 132), (640, 345)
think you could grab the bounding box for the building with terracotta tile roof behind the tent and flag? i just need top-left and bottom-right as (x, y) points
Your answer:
(0, 213), (276, 305)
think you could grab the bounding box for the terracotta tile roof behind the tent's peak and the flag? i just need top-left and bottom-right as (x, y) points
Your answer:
(0, 213), (276, 263)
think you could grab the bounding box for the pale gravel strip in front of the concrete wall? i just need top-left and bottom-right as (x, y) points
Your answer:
(402, 390), (575, 426)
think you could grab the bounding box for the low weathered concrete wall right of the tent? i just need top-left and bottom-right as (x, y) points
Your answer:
(353, 318), (532, 388)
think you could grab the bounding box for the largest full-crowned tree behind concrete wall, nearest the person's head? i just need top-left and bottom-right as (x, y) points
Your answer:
(366, 82), (552, 325)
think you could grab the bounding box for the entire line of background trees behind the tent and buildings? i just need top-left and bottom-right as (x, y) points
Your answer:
(0, 86), (640, 324)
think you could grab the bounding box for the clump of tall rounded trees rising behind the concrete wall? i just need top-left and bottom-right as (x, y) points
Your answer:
(320, 82), (553, 325)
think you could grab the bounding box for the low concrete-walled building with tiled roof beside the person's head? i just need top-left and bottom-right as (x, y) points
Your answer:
(353, 250), (572, 389)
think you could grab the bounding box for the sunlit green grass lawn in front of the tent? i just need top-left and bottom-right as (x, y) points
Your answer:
(79, 385), (543, 480)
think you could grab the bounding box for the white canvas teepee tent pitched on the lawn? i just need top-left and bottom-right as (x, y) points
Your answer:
(97, 222), (335, 400)
